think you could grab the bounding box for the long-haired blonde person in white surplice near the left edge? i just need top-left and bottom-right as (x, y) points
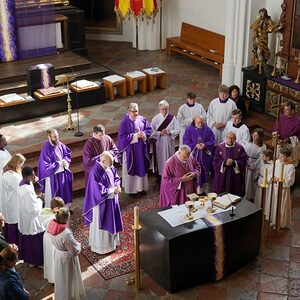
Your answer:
(0, 153), (25, 245)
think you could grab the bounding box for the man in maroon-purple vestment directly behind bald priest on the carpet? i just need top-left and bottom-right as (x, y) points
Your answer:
(82, 124), (118, 183)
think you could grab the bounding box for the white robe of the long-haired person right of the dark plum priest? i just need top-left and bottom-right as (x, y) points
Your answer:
(244, 142), (267, 200)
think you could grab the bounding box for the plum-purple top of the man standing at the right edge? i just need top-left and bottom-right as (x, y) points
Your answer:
(272, 115), (300, 139)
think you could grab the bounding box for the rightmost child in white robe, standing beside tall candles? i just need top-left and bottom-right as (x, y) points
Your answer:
(268, 145), (296, 228)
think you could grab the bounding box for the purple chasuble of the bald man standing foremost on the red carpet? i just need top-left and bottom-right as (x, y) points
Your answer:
(82, 163), (123, 234)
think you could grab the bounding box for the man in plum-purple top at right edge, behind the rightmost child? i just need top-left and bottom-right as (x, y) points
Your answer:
(272, 101), (300, 167)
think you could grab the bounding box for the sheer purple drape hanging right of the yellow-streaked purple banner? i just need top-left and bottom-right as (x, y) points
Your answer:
(15, 0), (56, 59)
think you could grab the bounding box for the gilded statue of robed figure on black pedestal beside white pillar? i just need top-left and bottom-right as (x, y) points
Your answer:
(250, 8), (278, 74)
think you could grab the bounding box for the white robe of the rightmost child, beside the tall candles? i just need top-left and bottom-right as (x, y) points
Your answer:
(271, 159), (296, 228)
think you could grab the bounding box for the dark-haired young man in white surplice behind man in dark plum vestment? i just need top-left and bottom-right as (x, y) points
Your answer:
(222, 109), (250, 148)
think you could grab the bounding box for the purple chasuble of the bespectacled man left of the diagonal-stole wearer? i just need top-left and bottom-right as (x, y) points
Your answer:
(118, 115), (151, 177)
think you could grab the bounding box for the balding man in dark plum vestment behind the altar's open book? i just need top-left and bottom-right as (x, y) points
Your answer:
(213, 131), (248, 197)
